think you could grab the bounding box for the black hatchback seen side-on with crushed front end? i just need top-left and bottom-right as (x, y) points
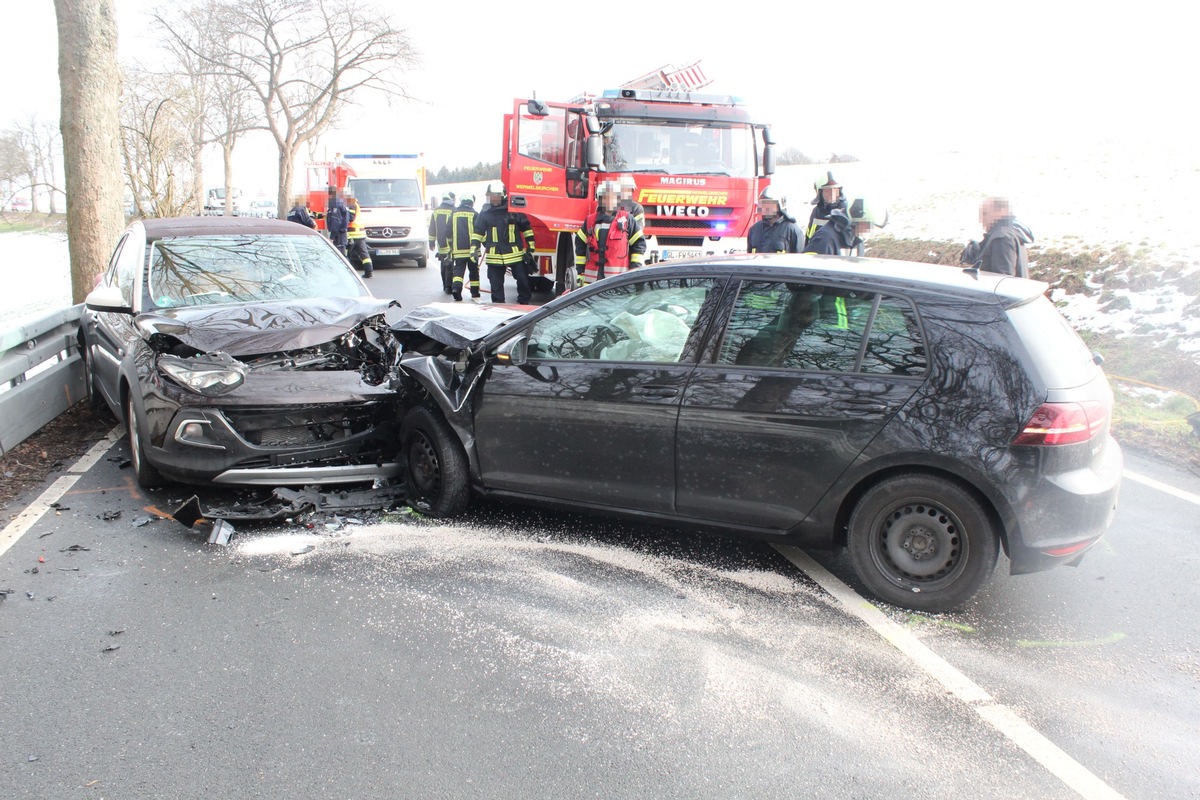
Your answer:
(394, 255), (1122, 610)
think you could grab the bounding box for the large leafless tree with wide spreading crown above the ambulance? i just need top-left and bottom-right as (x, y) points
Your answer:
(155, 0), (416, 210)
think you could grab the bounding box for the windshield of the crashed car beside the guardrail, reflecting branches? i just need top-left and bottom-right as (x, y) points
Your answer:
(146, 234), (366, 308)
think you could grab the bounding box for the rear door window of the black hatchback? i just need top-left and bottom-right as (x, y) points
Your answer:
(716, 281), (875, 372)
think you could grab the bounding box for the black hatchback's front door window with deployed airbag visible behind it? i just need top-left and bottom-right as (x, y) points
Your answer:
(529, 278), (716, 363)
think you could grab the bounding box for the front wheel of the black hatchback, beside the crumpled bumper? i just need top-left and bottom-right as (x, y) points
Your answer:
(400, 407), (468, 517)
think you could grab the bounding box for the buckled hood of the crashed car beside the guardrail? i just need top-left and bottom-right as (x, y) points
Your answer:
(137, 297), (392, 356)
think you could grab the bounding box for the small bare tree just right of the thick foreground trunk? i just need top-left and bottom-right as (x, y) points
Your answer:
(120, 67), (193, 217)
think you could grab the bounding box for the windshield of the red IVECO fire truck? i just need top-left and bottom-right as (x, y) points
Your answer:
(604, 118), (757, 178)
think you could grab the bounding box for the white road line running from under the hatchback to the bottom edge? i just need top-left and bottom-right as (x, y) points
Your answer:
(775, 545), (1123, 800)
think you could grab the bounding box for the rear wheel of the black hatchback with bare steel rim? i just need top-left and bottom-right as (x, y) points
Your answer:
(848, 475), (1000, 613)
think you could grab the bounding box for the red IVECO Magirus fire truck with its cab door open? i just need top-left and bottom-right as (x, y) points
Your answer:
(500, 65), (775, 293)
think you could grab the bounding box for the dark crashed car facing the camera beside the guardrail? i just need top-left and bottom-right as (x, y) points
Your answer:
(80, 217), (400, 487)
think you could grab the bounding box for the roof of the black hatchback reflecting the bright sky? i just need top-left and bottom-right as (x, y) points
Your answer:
(652, 253), (1048, 305)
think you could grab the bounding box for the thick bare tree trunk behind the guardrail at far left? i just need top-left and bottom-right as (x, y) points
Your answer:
(54, 0), (125, 302)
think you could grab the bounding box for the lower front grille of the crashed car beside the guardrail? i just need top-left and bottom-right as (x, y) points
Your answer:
(224, 402), (395, 447)
